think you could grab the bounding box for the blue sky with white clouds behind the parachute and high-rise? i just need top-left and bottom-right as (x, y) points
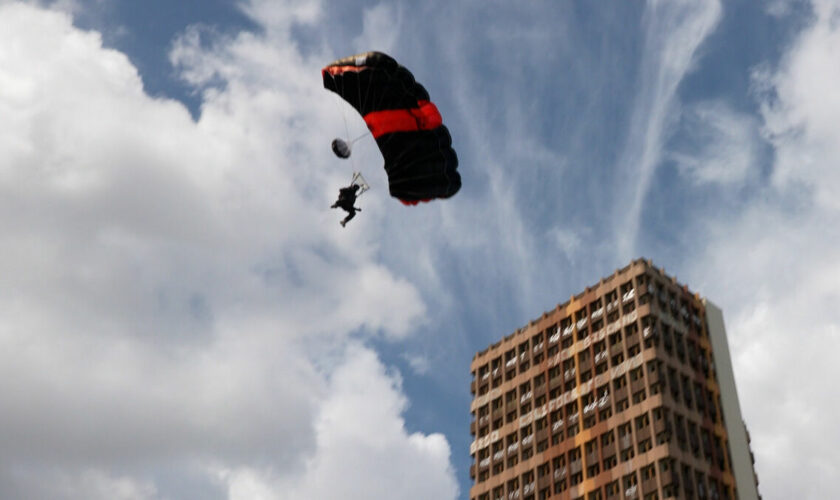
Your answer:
(0, 0), (840, 500)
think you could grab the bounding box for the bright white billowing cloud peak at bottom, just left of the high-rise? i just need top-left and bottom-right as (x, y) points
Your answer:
(213, 346), (458, 500)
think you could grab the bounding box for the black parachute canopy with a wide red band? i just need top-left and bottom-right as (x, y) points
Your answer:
(321, 52), (461, 205)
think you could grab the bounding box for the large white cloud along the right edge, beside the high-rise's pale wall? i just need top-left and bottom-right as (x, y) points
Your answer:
(689, 1), (840, 499)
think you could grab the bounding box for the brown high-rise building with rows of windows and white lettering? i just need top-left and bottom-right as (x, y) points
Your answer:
(470, 260), (760, 500)
